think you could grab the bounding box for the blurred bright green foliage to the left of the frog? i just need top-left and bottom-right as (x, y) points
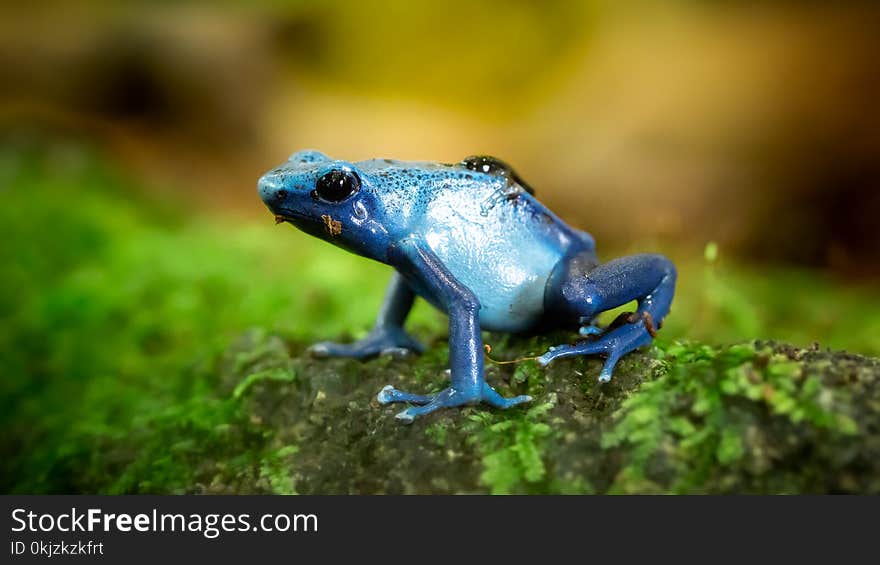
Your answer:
(0, 145), (436, 492)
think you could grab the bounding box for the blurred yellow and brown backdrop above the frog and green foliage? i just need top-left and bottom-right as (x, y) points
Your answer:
(6, 0), (880, 268)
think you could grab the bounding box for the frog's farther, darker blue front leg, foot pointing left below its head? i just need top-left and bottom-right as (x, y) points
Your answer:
(309, 273), (425, 359)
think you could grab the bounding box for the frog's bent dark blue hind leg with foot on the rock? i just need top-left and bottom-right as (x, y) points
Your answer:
(538, 254), (676, 382)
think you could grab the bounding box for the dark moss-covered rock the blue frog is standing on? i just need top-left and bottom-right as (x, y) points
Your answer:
(215, 331), (880, 493)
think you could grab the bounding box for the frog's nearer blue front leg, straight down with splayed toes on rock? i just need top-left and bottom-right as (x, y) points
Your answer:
(377, 239), (531, 423)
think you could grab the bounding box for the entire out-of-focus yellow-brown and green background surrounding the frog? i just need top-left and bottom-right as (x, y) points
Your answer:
(0, 0), (880, 491)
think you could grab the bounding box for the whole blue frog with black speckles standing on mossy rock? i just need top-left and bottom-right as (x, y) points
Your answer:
(258, 151), (676, 423)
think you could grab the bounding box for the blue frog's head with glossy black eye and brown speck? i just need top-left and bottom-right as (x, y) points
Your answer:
(257, 150), (388, 259)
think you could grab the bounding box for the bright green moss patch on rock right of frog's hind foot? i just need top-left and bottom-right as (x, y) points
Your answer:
(602, 342), (858, 492)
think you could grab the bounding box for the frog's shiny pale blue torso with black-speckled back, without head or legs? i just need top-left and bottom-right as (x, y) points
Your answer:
(360, 161), (572, 332)
